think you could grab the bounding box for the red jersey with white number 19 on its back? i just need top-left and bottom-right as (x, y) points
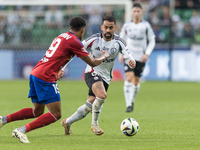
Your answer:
(31, 31), (89, 82)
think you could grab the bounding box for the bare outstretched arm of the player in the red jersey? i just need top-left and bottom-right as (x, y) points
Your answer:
(81, 50), (110, 67)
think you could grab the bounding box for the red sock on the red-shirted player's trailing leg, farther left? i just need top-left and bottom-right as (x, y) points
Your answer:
(6, 108), (35, 123)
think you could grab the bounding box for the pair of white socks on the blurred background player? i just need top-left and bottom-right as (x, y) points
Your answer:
(124, 81), (140, 107)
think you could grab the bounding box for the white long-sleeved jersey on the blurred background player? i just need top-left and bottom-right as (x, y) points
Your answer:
(120, 20), (155, 61)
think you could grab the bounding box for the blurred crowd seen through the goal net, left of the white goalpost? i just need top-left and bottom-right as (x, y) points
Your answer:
(0, 5), (124, 45)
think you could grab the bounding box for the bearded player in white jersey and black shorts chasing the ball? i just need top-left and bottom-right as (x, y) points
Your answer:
(61, 16), (136, 135)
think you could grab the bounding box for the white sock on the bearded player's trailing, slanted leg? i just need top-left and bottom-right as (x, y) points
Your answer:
(66, 102), (92, 125)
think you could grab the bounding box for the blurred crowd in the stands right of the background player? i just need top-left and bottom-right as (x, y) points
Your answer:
(146, 0), (200, 45)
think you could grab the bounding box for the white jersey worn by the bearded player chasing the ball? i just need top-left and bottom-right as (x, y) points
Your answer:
(82, 33), (134, 84)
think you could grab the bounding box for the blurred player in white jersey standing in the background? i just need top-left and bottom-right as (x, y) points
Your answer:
(119, 3), (155, 112)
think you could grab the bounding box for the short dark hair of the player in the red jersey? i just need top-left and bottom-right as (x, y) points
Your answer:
(69, 17), (86, 31)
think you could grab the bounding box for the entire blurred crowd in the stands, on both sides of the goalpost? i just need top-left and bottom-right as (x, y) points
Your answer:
(0, 0), (200, 48)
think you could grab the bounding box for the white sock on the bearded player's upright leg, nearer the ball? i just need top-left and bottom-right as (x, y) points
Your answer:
(92, 97), (105, 125)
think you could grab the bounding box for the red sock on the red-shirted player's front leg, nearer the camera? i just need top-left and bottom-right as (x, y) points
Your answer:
(25, 112), (58, 132)
